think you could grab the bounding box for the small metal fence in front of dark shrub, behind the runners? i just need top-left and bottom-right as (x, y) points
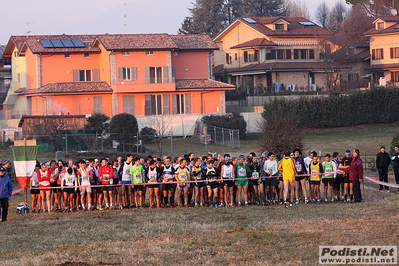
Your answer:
(198, 123), (240, 149)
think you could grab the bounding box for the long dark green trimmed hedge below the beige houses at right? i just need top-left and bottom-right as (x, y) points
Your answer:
(262, 88), (399, 128)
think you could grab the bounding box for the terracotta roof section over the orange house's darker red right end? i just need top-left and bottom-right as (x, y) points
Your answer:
(170, 34), (219, 50)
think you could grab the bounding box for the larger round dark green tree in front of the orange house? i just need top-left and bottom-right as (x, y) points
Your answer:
(109, 113), (139, 151)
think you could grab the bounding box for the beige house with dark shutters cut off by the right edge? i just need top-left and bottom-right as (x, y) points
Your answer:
(363, 16), (399, 86)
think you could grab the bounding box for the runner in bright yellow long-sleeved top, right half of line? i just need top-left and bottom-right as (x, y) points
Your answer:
(278, 151), (298, 208)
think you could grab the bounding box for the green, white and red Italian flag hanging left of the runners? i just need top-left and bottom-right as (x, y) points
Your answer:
(12, 146), (38, 189)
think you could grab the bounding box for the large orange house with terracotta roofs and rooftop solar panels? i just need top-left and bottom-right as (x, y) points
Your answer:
(5, 34), (235, 116)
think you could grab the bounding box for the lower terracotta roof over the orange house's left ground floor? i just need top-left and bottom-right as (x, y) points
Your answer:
(21, 81), (112, 95)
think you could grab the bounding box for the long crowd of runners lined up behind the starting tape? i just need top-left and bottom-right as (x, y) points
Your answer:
(25, 149), (363, 213)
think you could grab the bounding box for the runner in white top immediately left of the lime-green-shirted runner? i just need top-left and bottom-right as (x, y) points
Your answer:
(118, 153), (133, 209)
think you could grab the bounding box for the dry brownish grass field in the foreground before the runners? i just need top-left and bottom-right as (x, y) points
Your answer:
(0, 189), (399, 265)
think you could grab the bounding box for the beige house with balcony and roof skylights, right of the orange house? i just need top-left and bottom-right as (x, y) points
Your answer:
(214, 17), (337, 94)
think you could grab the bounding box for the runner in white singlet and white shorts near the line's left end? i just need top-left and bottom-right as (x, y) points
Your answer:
(76, 160), (93, 211)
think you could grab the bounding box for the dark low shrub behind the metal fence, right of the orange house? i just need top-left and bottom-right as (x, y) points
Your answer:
(202, 113), (247, 139)
